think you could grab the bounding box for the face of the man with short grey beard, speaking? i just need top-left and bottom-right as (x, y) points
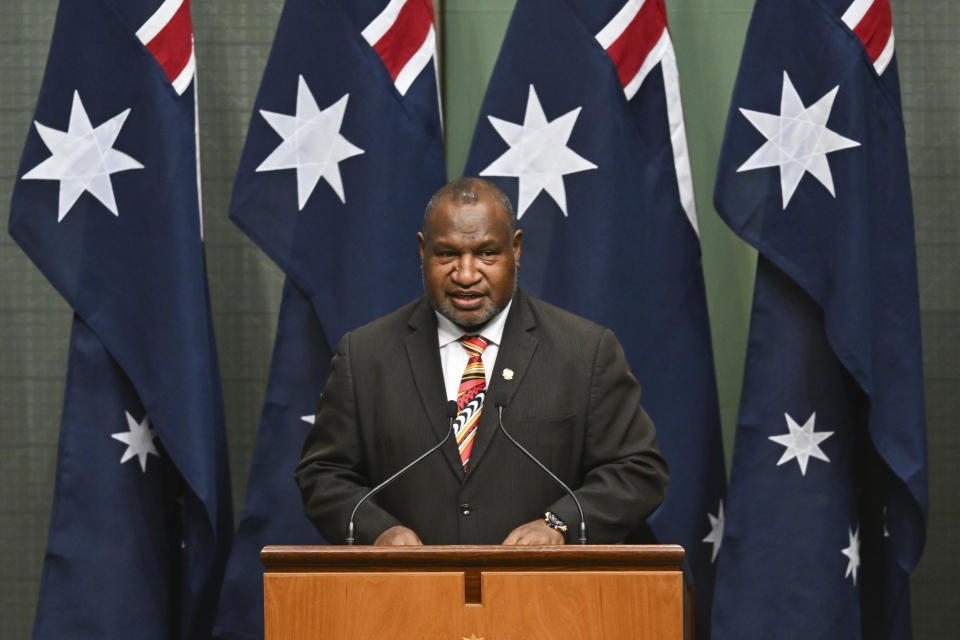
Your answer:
(417, 194), (521, 333)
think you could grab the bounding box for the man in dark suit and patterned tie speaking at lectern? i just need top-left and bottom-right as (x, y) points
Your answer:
(296, 178), (667, 544)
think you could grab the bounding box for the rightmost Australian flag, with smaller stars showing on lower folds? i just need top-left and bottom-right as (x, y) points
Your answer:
(713, 0), (927, 638)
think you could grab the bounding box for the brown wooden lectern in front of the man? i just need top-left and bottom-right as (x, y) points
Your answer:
(260, 545), (684, 640)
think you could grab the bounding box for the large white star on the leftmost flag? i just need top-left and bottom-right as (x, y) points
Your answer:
(22, 91), (143, 222)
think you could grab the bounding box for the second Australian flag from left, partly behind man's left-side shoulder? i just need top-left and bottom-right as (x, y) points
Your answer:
(216, 0), (445, 638)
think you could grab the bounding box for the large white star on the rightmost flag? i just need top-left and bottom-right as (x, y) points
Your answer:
(737, 71), (860, 209)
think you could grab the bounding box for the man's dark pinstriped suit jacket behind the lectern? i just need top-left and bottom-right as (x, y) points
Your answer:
(296, 291), (667, 544)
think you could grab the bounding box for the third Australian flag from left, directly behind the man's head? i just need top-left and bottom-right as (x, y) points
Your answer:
(466, 0), (725, 633)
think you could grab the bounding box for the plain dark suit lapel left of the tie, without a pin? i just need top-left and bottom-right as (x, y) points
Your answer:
(404, 299), (464, 478)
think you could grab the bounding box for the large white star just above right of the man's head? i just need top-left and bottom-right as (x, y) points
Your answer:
(480, 84), (597, 219)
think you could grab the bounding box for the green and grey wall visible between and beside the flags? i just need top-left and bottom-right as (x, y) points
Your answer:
(0, 0), (960, 639)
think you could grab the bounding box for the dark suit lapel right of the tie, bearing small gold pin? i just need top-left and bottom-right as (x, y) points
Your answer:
(465, 291), (537, 480)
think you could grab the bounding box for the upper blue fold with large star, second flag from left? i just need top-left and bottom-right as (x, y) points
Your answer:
(230, 0), (445, 344)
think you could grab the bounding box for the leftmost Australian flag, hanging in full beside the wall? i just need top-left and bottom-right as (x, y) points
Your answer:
(10, 0), (233, 640)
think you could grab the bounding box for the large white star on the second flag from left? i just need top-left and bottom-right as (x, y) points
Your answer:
(256, 76), (363, 211)
